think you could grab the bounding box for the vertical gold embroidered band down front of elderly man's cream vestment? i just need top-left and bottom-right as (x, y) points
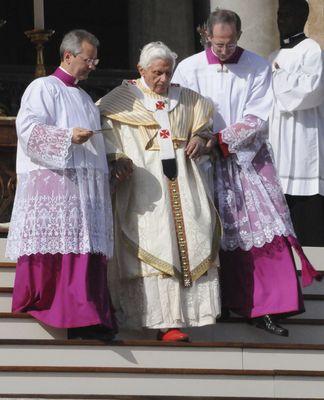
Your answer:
(168, 179), (192, 287)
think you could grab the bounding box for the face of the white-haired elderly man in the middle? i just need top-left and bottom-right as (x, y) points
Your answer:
(138, 59), (172, 94)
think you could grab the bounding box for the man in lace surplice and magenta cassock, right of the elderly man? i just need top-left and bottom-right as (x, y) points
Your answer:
(173, 9), (316, 336)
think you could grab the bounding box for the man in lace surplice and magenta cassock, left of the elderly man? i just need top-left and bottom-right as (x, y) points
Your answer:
(7, 30), (114, 339)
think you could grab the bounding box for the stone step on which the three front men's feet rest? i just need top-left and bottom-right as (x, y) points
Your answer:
(0, 313), (324, 344)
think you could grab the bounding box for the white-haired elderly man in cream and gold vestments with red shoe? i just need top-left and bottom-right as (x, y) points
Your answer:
(99, 42), (220, 341)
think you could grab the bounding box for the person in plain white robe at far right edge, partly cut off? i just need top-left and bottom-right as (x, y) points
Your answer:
(270, 0), (324, 246)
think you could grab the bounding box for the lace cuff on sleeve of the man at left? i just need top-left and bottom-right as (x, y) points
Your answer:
(27, 124), (73, 168)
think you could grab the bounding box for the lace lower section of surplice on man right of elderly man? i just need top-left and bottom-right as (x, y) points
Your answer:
(214, 138), (295, 251)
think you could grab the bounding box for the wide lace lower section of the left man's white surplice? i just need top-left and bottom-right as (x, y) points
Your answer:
(6, 168), (113, 259)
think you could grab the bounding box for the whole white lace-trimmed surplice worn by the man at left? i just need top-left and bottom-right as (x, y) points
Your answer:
(6, 76), (113, 259)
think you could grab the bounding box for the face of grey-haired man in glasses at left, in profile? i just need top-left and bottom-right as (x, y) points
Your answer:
(64, 42), (97, 81)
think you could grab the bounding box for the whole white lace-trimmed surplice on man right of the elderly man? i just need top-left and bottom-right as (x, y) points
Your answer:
(172, 50), (294, 250)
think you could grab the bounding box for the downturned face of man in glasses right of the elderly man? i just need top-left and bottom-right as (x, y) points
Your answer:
(208, 23), (241, 61)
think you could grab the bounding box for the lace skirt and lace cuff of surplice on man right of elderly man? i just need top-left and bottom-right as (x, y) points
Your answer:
(215, 115), (294, 250)
